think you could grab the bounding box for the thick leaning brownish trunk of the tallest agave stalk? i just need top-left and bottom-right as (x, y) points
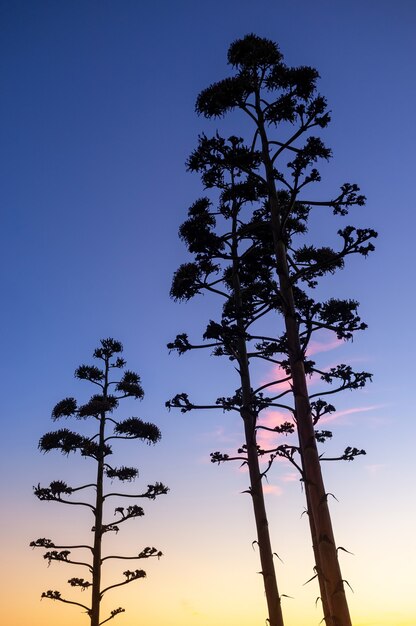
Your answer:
(257, 106), (351, 626)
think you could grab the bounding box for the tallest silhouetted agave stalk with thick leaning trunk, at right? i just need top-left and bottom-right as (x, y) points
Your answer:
(174, 35), (376, 626)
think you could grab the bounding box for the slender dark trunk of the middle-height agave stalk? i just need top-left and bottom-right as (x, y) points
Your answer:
(233, 211), (284, 626)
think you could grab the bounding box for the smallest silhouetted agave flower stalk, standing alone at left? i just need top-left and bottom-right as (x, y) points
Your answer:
(30, 339), (168, 626)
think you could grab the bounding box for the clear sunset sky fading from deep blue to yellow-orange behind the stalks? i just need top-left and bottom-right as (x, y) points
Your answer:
(0, 0), (416, 626)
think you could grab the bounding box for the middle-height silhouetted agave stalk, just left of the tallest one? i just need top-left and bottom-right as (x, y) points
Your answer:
(167, 193), (283, 626)
